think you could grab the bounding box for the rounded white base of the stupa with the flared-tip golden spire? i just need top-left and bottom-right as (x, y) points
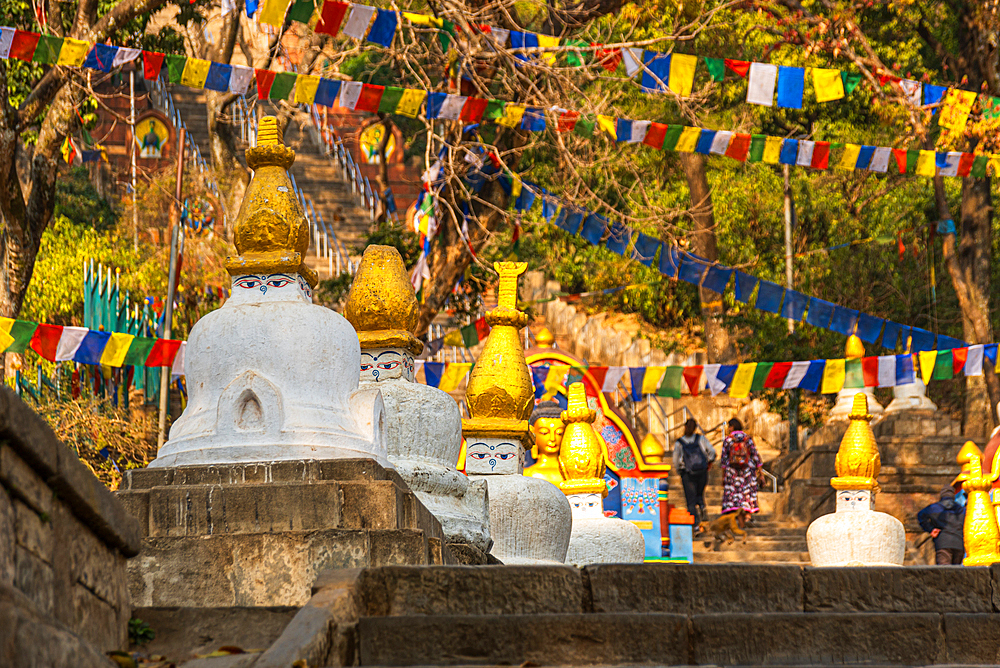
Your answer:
(469, 470), (573, 565)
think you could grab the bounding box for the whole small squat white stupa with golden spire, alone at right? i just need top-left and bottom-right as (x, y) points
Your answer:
(806, 392), (906, 566)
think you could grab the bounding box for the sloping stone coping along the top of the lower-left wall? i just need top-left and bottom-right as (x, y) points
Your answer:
(0, 387), (142, 557)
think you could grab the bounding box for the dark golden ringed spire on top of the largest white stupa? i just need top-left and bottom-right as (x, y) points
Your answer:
(225, 116), (318, 287)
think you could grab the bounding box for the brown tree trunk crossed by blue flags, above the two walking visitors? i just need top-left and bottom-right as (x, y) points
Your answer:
(679, 153), (736, 364)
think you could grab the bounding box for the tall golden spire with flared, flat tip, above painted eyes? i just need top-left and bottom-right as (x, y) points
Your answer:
(462, 262), (535, 447)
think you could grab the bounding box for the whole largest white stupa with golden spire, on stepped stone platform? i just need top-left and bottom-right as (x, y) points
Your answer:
(150, 116), (391, 467)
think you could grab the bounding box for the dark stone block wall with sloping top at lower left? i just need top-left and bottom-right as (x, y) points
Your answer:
(0, 387), (140, 665)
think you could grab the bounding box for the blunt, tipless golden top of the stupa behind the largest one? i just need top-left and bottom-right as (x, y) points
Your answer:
(344, 246), (424, 355)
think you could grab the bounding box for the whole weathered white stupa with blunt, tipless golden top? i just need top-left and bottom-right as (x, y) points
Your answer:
(344, 246), (490, 553)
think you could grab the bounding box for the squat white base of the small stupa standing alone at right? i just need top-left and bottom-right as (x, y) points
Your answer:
(806, 510), (906, 566)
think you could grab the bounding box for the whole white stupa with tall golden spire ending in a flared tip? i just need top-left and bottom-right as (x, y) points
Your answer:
(462, 262), (572, 564)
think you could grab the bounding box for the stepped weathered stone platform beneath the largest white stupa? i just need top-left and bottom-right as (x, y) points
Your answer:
(118, 459), (487, 607)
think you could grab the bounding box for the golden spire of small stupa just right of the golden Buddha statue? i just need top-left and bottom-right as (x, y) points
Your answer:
(559, 383), (608, 496)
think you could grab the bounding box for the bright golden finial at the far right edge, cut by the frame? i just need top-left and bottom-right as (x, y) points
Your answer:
(957, 441), (1000, 566)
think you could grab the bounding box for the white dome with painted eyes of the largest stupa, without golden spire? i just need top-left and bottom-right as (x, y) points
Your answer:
(150, 274), (391, 467)
